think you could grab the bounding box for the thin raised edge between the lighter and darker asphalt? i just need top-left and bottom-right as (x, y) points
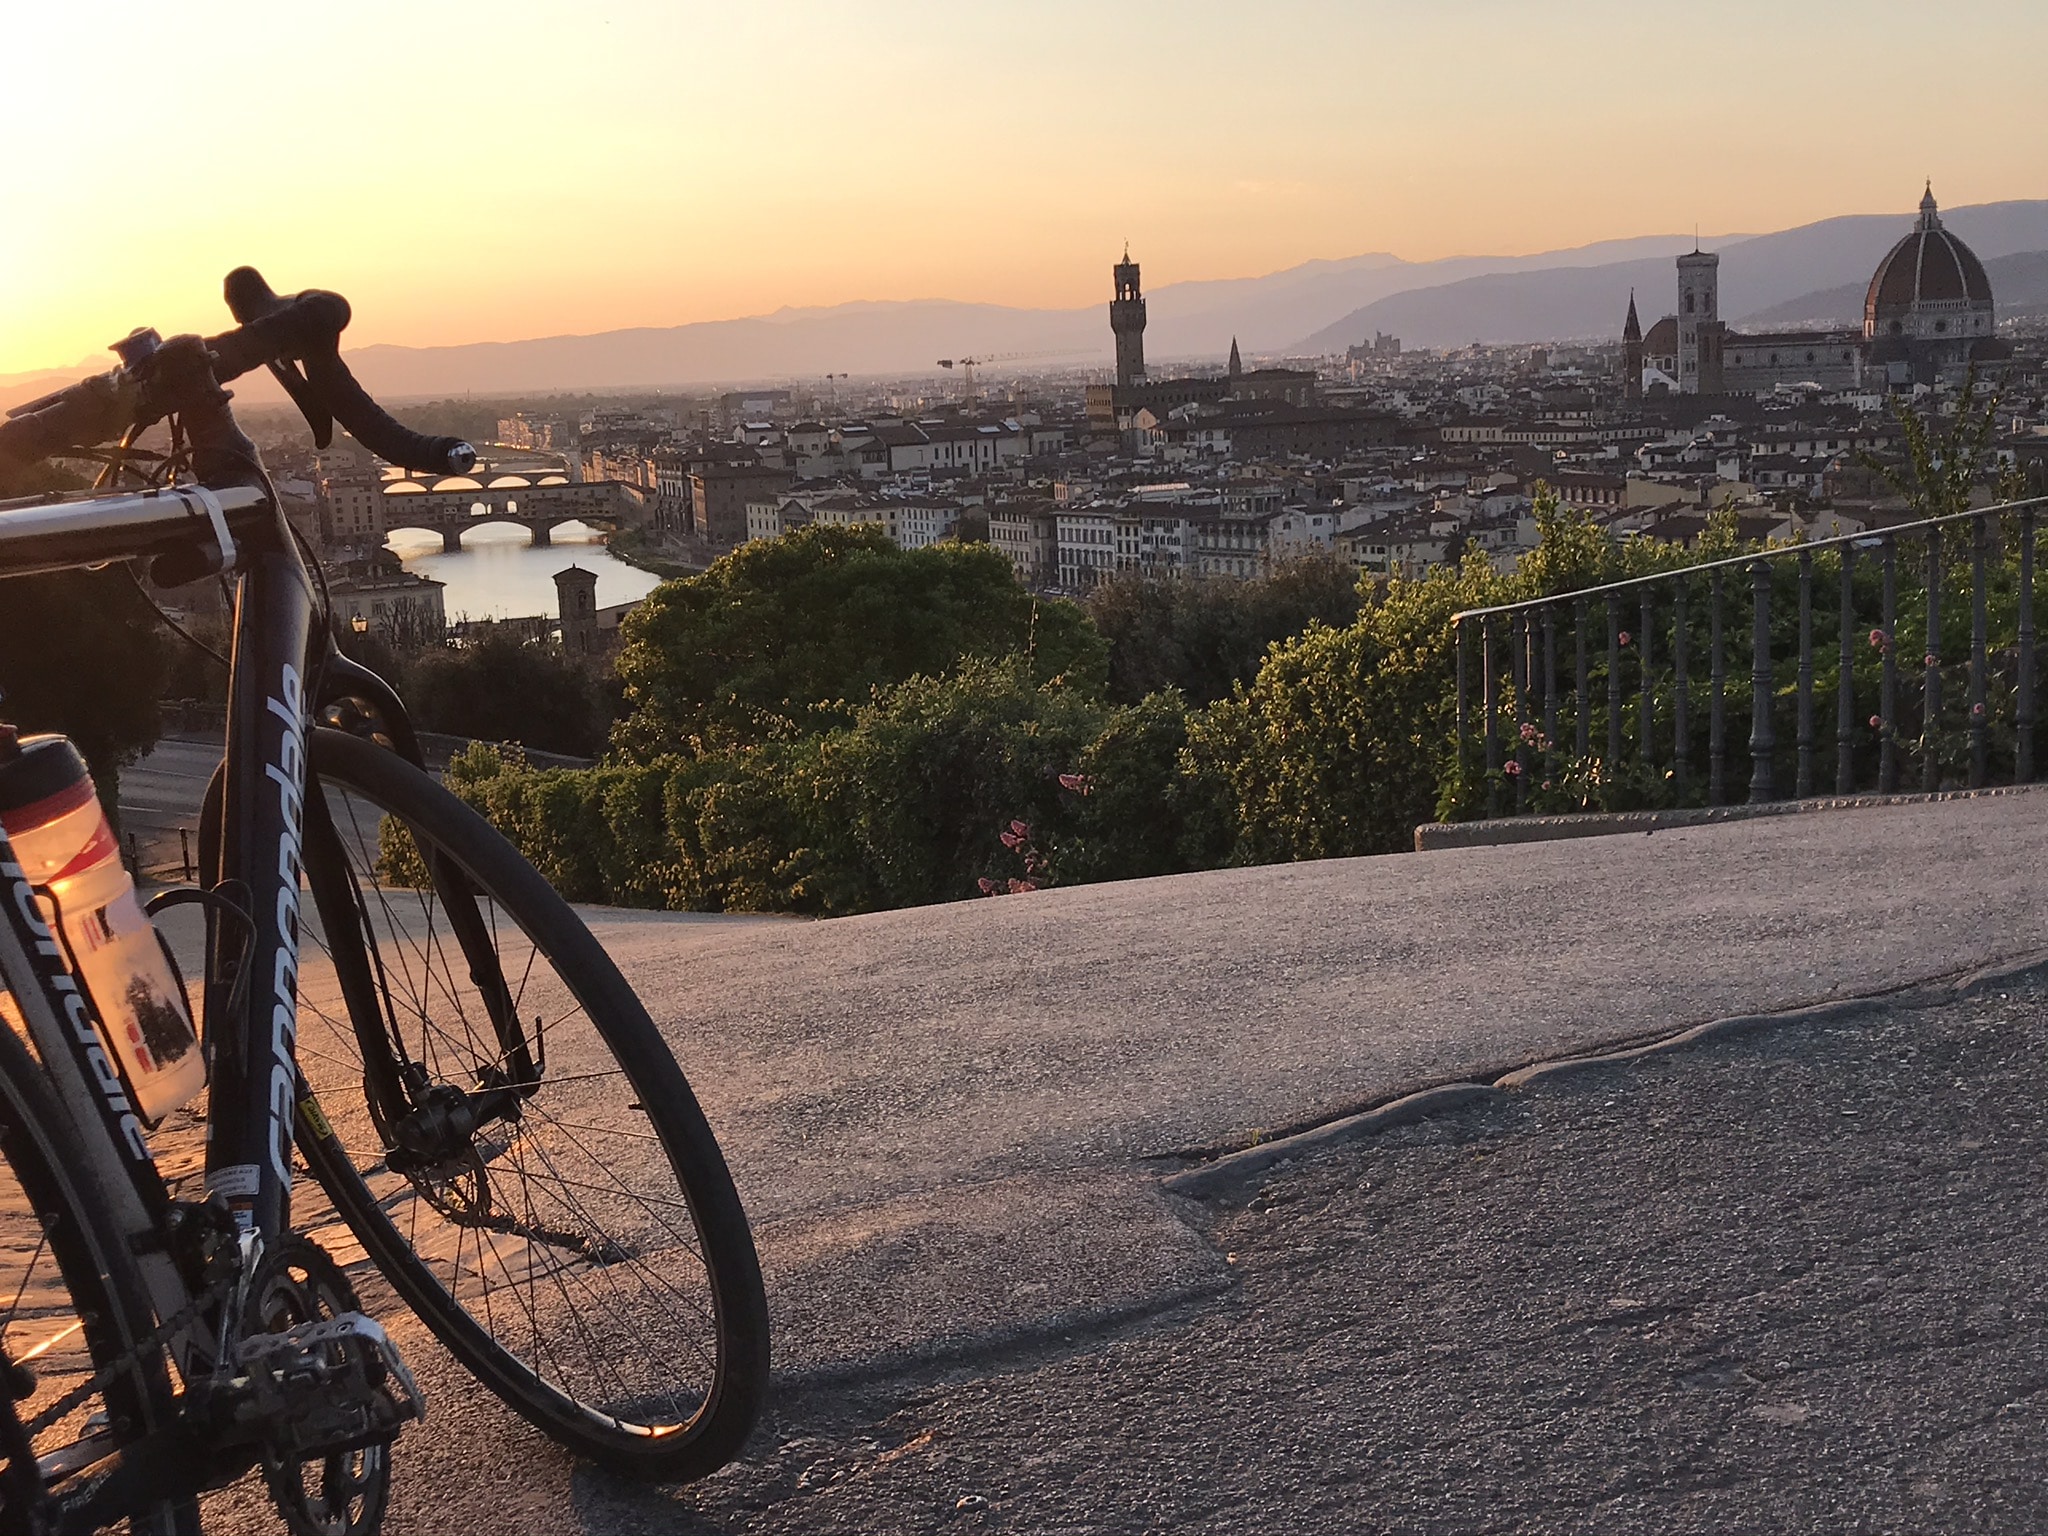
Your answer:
(1159, 950), (2048, 1200)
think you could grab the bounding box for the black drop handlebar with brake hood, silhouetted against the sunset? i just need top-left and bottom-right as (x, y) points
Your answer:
(0, 266), (477, 475)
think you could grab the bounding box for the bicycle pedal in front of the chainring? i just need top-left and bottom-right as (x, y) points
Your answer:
(236, 1313), (426, 1460)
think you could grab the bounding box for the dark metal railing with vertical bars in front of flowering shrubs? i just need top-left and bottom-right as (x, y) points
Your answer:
(1452, 498), (2048, 815)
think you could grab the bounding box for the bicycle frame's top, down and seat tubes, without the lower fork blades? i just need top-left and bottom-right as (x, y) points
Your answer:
(0, 468), (436, 1327)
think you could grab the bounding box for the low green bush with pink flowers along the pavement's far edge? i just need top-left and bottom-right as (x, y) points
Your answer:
(449, 657), (1229, 915)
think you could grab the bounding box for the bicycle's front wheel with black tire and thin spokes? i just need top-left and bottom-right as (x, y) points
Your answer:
(299, 729), (768, 1481)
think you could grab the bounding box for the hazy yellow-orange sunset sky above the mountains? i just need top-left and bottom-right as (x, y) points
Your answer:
(0, 0), (2048, 373)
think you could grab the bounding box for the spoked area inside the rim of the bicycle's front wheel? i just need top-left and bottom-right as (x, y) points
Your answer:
(305, 782), (745, 1432)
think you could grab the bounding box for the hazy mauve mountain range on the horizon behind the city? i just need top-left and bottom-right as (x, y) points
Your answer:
(0, 199), (2048, 408)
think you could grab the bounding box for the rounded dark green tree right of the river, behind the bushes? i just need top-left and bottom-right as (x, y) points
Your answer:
(614, 526), (1106, 760)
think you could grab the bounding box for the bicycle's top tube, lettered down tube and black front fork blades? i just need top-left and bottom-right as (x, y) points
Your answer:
(0, 354), (539, 1269)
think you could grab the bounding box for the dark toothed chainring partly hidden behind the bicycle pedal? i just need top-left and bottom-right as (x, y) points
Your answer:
(242, 1233), (391, 1536)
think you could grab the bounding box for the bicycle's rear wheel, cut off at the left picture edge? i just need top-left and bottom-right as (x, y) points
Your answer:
(0, 1011), (199, 1536)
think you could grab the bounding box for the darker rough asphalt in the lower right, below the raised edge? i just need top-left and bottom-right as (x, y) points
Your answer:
(618, 966), (2048, 1536)
